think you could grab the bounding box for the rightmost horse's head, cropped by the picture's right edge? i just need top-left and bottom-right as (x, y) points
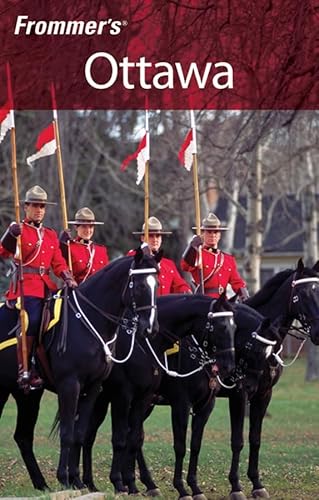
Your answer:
(289, 259), (319, 345)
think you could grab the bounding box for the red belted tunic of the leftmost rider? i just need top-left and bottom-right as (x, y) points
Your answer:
(0, 221), (68, 300)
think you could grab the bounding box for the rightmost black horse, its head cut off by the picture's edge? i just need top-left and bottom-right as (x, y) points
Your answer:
(225, 260), (319, 500)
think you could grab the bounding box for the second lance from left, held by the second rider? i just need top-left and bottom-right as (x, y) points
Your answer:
(51, 83), (72, 271)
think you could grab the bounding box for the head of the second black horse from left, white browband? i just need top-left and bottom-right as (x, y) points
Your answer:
(202, 294), (236, 377)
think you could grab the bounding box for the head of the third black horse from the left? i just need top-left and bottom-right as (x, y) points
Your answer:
(233, 304), (281, 398)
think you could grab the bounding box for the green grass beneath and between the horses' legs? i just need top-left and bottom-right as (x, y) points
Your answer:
(0, 360), (319, 500)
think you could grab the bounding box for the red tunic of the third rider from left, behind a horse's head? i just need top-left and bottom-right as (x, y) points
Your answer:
(127, 250), (191, 296)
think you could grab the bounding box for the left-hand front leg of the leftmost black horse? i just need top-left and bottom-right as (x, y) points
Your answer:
(56, 377), (80, 488)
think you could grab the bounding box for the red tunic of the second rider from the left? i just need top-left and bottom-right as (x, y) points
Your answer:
(70, 239), (109, 283)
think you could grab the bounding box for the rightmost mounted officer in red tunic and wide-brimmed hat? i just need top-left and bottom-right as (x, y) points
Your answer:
(181, 212), (248, 301)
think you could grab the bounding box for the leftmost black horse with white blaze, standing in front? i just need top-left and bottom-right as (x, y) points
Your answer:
(0, 250), (158, 489)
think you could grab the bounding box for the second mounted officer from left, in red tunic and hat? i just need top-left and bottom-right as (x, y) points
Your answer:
(60, 207), (109, 284)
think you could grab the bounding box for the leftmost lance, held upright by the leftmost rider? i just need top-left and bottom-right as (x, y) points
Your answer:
(6, 63), (29, 381)
